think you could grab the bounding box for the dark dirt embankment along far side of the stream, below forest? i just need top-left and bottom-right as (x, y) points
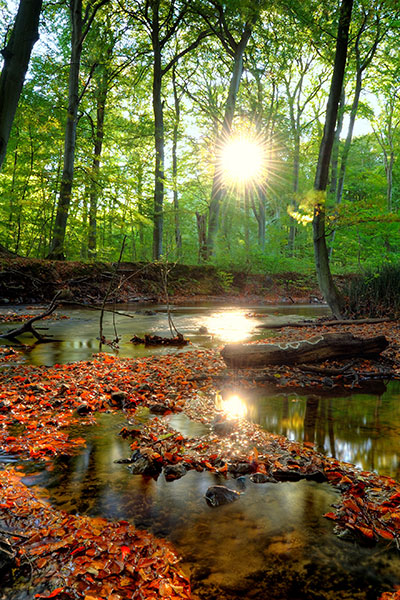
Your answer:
(0, 257), (321, 304)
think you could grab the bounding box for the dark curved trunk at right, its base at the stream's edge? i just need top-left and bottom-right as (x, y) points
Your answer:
(313, 0), (353, 318)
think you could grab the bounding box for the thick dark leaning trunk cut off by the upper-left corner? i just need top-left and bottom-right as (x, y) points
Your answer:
(0, 0), (42, 169)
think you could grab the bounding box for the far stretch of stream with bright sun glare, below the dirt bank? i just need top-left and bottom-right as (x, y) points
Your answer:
(0, 304), (329, 366)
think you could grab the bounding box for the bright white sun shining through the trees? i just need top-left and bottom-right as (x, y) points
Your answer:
(221, 135), (265, 185)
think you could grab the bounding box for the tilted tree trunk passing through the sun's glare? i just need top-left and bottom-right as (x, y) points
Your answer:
(206, 25), (252, 258)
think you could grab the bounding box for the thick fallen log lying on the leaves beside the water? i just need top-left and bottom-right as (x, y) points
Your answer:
(221, 333), (389, 368)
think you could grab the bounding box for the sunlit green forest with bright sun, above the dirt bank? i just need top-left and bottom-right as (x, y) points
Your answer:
(0, 0), (400, 292)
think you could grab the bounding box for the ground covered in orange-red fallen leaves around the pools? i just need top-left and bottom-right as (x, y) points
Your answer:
(0, 323), (400, 600)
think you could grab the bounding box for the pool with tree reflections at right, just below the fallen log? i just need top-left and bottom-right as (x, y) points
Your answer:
(249, 382), (400, 478)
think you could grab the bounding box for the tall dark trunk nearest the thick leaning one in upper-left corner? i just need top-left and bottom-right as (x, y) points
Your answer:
(48, 0), (82, 260)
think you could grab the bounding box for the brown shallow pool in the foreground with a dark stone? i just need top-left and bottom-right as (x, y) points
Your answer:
(21, 414), (400, 600)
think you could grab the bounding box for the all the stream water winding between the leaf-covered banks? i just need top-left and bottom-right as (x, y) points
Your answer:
(1, 305), (400, 600)
